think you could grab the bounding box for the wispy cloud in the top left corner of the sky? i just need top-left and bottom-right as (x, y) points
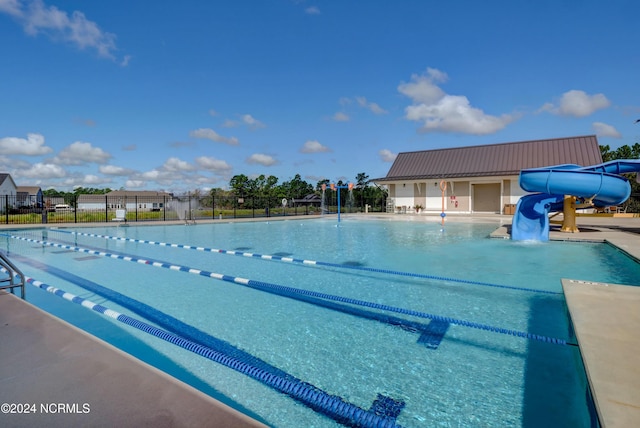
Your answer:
(0, 0), (124, 61)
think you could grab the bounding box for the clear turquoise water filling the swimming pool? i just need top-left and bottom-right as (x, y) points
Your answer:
(0, 218), (640, 427)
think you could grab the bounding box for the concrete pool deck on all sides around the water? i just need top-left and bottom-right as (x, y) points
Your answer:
(0, 214), (640, 428)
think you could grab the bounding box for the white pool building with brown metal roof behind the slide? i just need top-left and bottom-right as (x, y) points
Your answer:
(372, 135), (602, 214)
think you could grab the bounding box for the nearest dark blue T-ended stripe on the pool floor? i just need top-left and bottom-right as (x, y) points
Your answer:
(12, 254), (405, 427)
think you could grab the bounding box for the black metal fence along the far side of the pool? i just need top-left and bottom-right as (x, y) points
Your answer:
(0, 192), (384, 224)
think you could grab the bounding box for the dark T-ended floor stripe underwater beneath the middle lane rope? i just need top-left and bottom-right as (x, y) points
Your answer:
(35, 234), (449, 350)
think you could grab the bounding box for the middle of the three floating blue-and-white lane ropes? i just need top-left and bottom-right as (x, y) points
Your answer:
(0, 233), (577, 346)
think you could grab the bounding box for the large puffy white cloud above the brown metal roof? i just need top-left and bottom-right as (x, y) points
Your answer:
(398, 68), (515, 135)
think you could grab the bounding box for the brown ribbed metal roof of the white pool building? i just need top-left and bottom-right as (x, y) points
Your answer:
(372, 135), (602, 182)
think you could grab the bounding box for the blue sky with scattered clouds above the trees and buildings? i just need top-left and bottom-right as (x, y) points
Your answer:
(0, 0), (640, 193)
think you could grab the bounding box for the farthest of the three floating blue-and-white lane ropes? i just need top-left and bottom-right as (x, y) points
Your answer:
(49, 228), (562, 295)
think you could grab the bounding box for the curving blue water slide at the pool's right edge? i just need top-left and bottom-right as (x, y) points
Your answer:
(511, 159), (640, 241)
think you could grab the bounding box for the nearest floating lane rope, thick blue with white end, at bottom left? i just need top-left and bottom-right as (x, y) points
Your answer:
(3, 262), (399, 427)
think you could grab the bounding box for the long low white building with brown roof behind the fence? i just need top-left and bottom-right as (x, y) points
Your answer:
(78, 190), (173, 212)
